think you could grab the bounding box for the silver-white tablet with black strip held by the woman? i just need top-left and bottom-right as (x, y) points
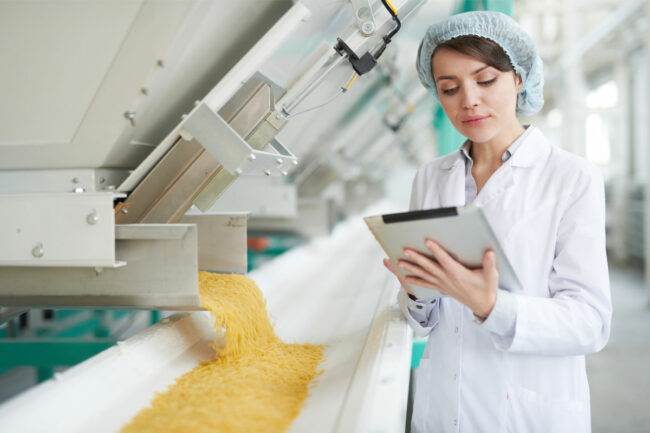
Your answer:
(364, 205), (521, 299)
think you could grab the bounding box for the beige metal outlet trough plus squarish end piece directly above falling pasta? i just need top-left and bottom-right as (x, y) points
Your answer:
(0, 213), (247, 310)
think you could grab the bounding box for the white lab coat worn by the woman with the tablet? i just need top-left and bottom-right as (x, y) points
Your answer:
(398, 126), (612, 433)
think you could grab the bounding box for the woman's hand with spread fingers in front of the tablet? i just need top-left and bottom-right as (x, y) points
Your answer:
(398, 239), (499, 319)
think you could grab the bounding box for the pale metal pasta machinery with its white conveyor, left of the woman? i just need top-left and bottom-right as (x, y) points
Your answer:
(0, 0), (455, 432)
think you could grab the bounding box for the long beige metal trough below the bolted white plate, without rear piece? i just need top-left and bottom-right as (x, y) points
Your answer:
(0, 224), (201, 310)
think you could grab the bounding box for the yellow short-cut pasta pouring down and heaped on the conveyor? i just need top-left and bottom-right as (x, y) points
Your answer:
(122, 272), (324, 433)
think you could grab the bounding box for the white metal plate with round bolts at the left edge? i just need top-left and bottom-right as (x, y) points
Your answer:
(0, 192), (124, 268)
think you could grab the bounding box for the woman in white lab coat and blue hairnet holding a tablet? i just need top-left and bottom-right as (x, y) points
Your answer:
(385, 12), (612, 433)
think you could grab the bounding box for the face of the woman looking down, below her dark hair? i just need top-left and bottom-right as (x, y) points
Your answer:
(431, 48), (521, 143)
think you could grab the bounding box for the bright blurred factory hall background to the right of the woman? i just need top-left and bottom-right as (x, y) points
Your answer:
(514, 0), (650, 432)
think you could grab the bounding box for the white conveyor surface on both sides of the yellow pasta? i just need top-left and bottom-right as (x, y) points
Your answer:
(0, 208), (412, 433)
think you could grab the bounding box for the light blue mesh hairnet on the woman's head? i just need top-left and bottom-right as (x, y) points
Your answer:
(416, 11), (544, 116)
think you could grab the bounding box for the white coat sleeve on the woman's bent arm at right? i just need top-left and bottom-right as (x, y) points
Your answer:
(481, 167), (612, 356)
